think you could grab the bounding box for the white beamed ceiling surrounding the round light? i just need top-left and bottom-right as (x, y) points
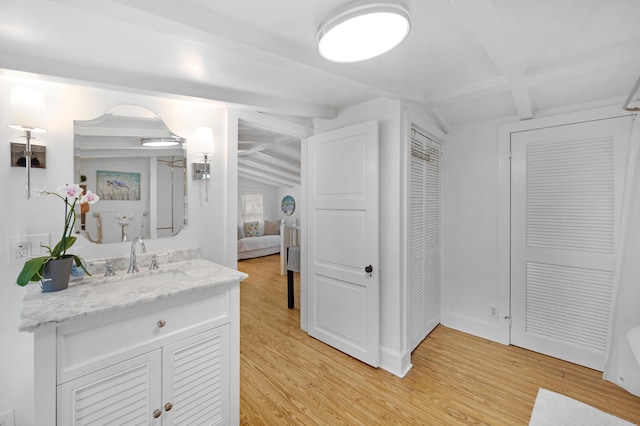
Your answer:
(0, 0), (640, 186)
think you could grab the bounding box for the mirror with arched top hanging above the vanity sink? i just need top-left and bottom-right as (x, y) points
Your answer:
(73, 105), (187, 244)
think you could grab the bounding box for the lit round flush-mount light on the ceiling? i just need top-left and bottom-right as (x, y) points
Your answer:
(316, 1), (411, 62)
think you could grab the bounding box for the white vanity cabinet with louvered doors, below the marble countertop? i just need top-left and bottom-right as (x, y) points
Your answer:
(29, 281), (240, 426)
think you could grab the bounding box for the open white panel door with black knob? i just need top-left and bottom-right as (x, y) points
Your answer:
(305, 121), (380, 367)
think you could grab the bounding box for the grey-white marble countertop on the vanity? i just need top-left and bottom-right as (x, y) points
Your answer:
(19, 258), (248, 331)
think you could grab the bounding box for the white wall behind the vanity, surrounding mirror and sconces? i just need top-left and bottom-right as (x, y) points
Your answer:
(0, 76), (230, 426)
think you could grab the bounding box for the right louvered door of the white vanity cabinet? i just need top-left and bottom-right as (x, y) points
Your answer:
(162, 325), (230, 426)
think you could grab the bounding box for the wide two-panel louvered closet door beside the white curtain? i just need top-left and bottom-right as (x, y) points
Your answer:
(511, 117), (631, 370)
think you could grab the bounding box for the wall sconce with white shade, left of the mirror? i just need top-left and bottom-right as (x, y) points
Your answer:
(7, 87), (47, 199)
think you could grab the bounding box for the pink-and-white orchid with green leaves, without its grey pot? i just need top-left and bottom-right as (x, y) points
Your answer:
(17, 184), (100, 286)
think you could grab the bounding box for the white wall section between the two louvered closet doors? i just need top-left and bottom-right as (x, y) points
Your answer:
(441, 117), (508, 340)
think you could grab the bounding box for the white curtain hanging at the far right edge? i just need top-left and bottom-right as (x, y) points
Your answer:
(603, 116), (640, 396)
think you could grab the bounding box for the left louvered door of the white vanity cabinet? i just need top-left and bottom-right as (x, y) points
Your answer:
(57, 350), (162, 426)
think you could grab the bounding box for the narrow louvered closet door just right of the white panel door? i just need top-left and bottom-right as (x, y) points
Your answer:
(408, 131), (440, 350)
